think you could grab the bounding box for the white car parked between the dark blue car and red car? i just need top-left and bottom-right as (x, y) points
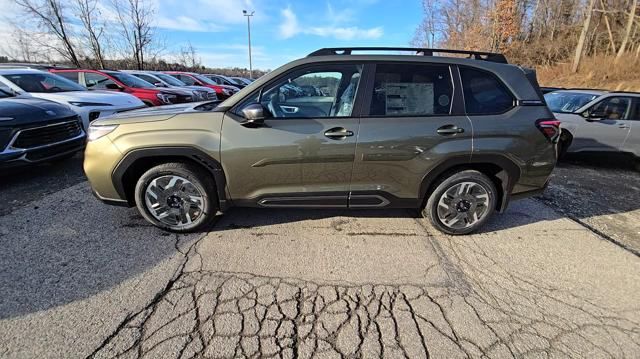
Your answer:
(0, 69), (145, 129)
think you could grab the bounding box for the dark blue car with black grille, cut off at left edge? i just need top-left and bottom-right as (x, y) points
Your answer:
(0, 89), (86, 168)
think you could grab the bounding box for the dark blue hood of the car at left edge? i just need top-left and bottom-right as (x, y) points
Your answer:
(0, 97), (76, 127)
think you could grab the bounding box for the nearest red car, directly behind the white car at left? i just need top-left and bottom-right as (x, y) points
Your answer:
(49, 69), (195, 106)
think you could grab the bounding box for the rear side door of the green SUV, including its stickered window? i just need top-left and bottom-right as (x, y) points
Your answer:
(349, 62), (472, 208)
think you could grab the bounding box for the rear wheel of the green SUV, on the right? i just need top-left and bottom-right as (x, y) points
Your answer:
(424, 170), (497, 235)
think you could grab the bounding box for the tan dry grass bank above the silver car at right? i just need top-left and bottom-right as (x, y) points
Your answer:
(537, 55), (640, 92)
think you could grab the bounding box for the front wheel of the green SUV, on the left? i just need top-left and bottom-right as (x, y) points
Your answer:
(135, 163), (218, 232)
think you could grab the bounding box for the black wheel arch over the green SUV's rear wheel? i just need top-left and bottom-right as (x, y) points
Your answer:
(420, 154), (520, 212)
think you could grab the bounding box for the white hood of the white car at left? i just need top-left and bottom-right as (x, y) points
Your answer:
(31, 91), (144, 108)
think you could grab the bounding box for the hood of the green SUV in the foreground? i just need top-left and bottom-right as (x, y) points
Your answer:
(93, 101), (220, 126)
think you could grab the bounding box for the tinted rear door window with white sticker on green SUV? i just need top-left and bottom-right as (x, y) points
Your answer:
(370, 64), (453, 116)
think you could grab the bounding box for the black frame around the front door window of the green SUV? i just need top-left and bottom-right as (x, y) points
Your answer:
(229, 61), (368, 121)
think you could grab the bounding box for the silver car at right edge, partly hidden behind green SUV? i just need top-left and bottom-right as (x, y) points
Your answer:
(545, 89), (640, 161)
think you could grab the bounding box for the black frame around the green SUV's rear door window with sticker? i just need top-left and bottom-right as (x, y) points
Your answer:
(362, 61), (456, 118)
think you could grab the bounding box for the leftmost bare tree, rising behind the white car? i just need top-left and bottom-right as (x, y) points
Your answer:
(15, 0), (80, 67)
